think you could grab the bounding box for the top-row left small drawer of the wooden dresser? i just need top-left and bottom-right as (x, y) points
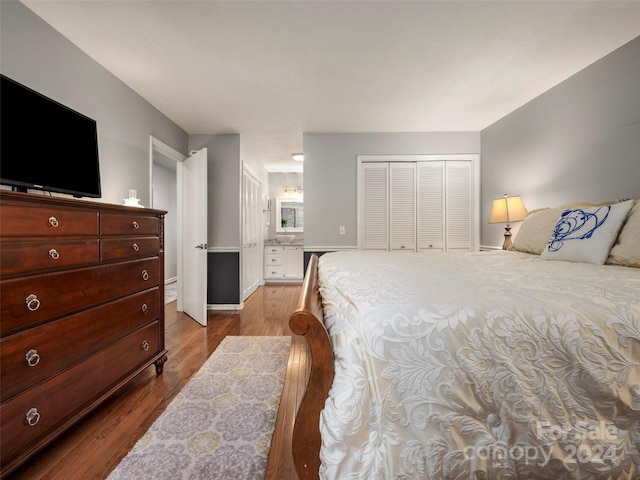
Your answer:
(0, 204), (98, 238)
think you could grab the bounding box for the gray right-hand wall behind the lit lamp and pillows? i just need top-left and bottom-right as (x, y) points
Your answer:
(481, 37), (640, 246)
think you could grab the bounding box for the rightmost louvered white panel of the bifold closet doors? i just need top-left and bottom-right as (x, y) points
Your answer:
(445, 161), (473, 252)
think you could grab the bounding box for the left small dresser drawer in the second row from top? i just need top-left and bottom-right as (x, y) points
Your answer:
(0, 238), (100, 275)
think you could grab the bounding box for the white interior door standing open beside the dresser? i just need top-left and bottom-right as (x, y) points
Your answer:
(180, 148), (207, 326)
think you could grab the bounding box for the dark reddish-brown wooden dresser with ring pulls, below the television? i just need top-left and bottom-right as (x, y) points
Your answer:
(0, 190), (167, 476)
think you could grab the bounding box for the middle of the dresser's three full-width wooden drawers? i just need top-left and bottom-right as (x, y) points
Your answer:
(0, 287), (160, 402)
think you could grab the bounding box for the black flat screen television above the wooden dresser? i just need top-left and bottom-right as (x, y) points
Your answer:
(0, 75), (101, 198)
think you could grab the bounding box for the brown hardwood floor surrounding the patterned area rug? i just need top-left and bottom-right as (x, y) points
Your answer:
(3, 285), (309, 480)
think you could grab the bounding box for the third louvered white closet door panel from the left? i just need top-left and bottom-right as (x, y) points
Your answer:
(417, 162), (445, 252)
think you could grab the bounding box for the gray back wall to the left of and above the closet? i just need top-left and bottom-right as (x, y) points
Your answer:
(303, 132), (480, 250)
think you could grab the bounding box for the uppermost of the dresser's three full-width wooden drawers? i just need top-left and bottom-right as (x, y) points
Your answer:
(0, 257), (160, 336)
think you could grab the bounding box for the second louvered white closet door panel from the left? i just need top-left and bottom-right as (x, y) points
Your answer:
(389, 163), (416, 252)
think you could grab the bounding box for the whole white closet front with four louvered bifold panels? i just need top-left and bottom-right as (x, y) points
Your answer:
(357, 155), (479, 252)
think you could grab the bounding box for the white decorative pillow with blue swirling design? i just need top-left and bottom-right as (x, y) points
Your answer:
(541, 200), (633, 265)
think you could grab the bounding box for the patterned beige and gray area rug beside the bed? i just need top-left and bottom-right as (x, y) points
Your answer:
(108, 336), (291, 480)
